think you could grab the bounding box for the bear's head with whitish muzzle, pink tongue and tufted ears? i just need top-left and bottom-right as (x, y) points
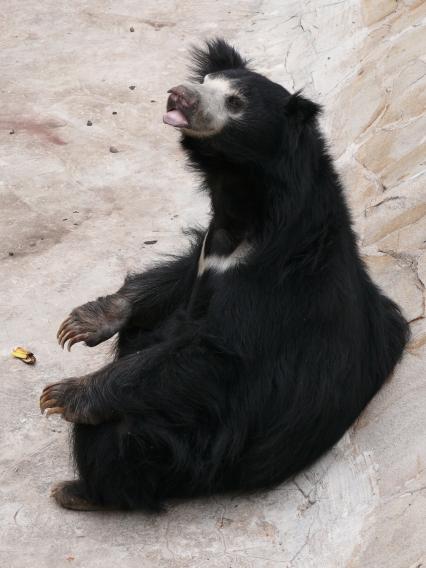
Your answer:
(163, 39), (319, 161)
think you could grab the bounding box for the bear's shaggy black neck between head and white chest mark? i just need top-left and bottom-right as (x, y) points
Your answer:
(183, 135), (349, 256)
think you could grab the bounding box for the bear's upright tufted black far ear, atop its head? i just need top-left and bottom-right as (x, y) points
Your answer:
(191, 38), (247, 81)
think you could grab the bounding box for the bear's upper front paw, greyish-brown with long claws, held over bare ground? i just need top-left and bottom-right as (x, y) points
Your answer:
(57, 294), (130, 351)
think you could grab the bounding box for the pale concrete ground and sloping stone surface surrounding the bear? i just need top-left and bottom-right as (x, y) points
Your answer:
(0, 0), (426, 568)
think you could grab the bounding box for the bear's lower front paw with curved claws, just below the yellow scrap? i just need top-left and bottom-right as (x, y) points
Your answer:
(40, 377), (103, 424)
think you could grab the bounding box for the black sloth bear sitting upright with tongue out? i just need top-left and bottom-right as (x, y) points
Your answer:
(40, 39), (408, 510)
